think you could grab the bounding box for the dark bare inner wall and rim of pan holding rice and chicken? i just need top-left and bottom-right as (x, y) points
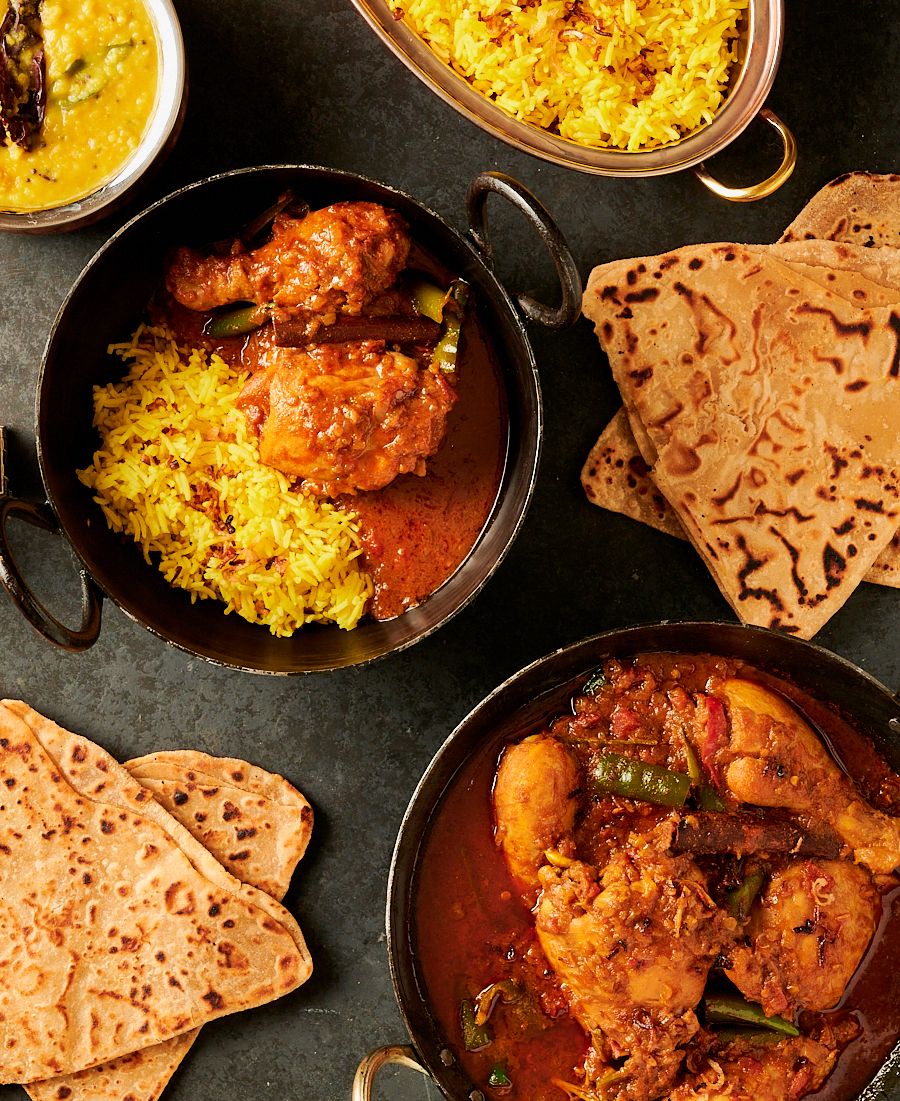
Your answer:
(35, 166), (541, 674)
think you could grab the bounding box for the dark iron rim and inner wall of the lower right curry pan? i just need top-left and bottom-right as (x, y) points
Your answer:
(387, 623), (900, 1101)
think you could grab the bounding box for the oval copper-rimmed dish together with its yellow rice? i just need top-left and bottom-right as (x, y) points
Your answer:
(353, 0), (792, 197)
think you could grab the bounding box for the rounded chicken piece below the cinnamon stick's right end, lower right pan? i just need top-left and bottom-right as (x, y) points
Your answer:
(728, 860), (880, 1016)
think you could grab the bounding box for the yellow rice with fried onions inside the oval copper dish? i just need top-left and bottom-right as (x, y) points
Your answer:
(389, 0), (749, 152)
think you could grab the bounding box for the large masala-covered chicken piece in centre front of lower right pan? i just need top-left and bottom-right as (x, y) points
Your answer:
(535, 833), (737, 1101)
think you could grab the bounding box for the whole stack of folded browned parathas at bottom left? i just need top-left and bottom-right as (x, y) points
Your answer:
(0, 700), (312, 1101)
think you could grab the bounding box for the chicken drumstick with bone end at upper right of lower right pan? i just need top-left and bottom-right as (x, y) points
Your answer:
(716, 678), (900, 873)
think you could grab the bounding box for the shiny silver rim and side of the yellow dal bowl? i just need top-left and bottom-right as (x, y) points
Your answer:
(0, 0), (187, 233)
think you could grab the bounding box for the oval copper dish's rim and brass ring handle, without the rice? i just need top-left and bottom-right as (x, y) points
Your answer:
(353, 0), (796, 200)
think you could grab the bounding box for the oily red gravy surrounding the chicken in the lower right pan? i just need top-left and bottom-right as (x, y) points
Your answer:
(412, 655), (900, 1101)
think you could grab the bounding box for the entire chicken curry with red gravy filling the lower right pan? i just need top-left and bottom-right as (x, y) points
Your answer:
(414, 654), (900, 1101)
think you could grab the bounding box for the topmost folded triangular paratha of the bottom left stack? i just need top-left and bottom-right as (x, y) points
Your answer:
(0, 700), (312, 1082)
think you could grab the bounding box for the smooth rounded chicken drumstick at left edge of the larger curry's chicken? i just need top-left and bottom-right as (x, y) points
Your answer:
(494, 734), (581, 905)
